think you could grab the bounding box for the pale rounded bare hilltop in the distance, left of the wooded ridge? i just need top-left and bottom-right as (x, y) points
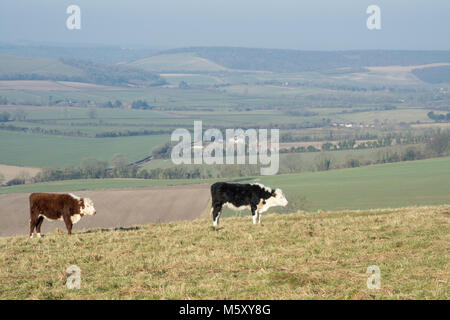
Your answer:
(128, 53), (227, 72)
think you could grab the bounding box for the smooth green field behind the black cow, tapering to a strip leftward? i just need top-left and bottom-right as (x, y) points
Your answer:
(0, 157), (450, 216)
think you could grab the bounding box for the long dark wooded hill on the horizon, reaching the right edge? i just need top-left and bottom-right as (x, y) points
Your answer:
(160, 47), (450, 72)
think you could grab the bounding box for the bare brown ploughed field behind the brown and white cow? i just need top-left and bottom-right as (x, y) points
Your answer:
(0, 185), (210, 237)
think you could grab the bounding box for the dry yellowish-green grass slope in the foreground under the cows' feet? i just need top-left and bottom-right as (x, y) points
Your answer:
(0, 206), (450, 299)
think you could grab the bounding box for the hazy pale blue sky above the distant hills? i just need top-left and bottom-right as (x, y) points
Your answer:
(0, 0), (450, 50)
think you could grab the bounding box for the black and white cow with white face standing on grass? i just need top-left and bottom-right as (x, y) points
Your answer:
(211, 182), (288, 226)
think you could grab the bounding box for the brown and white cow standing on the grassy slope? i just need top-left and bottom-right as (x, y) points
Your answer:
(30, 193), (96, 238)
